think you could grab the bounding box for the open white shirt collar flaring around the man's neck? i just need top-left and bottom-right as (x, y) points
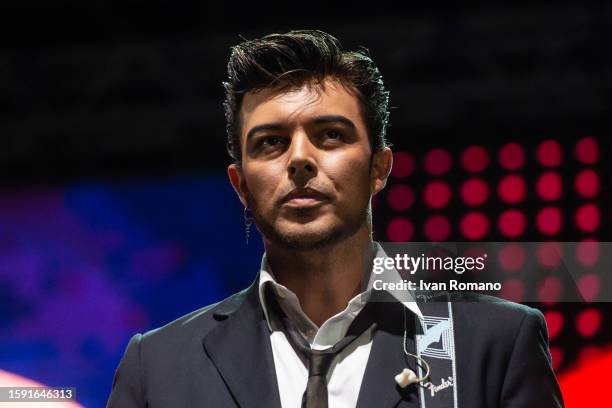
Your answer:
(259, 242), (423, 331)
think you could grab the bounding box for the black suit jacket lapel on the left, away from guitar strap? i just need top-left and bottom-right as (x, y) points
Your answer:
(202, 279), (281, 408)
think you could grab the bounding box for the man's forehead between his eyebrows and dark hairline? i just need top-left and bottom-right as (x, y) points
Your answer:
(240, 79), (365, 136)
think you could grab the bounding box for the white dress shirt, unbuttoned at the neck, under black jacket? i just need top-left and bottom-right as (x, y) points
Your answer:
(259, 243), (422, 408)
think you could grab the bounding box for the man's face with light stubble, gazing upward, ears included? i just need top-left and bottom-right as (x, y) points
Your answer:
(228, 79), (390, 249)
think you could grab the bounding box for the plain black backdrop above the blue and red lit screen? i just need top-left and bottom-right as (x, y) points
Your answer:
(0, 0), (612, 182)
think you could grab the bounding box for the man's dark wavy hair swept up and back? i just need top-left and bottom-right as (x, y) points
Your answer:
(223, 30), (389, 166)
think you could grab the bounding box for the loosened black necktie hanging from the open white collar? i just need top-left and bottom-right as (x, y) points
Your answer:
(266, 285), (376, 408)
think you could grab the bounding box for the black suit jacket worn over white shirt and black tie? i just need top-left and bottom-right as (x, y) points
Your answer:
(108, 279), (563, 408)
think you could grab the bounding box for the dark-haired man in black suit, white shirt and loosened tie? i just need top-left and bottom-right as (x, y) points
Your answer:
(108, 30), (562, 408)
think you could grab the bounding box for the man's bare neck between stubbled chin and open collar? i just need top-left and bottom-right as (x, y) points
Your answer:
(264, 226), (373, 326)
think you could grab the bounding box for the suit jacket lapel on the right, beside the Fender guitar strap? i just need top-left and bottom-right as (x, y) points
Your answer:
(357, 301), (419, 408)
